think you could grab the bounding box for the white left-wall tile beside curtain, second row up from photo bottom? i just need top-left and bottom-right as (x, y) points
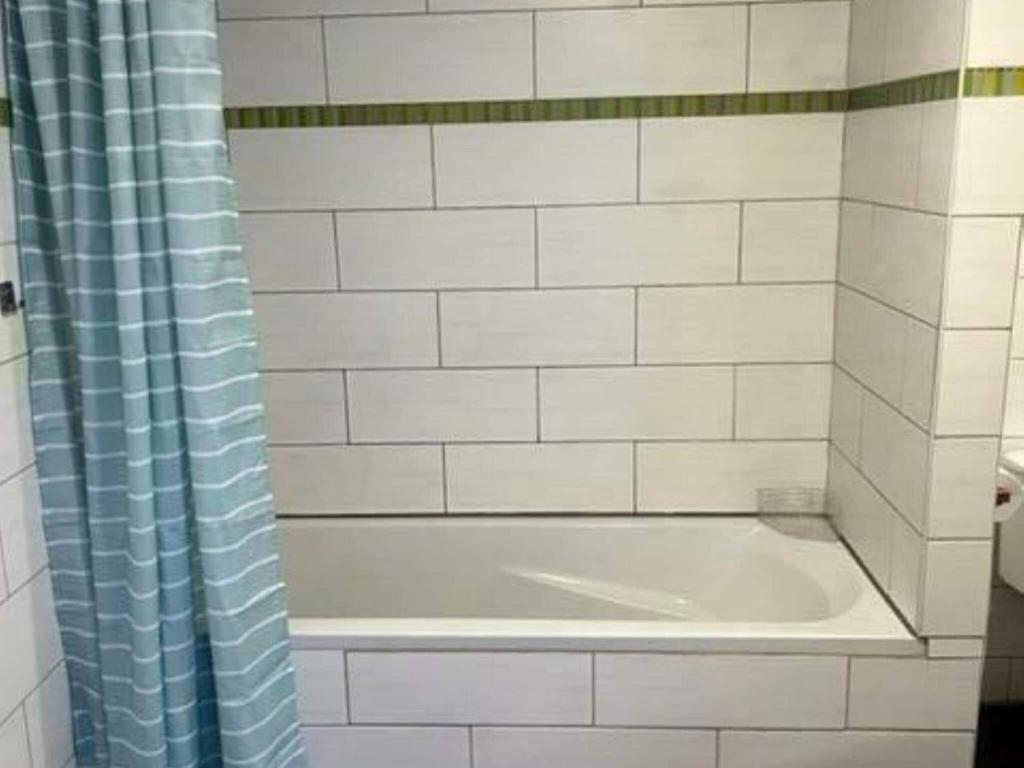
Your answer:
(0, 570), (60, 719)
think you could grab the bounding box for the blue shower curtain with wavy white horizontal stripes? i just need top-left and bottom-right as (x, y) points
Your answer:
(4, 0), (304, 768)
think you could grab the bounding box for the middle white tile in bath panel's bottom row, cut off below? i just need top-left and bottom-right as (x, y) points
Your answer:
(473, 728), (717, 768)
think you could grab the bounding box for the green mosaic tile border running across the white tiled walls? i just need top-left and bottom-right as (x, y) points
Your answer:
(0, 67), (1024, 129)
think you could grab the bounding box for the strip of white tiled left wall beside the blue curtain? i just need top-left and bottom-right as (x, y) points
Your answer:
(0, 72), (73, 768)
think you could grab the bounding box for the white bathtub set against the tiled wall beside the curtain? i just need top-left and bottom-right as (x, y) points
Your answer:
(281, 517), (921, 655)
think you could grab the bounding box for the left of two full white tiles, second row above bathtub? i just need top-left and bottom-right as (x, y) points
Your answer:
(348, 371), (537, 442)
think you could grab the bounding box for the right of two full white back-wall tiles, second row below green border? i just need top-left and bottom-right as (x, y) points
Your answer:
(538, 203), (739, 286)
